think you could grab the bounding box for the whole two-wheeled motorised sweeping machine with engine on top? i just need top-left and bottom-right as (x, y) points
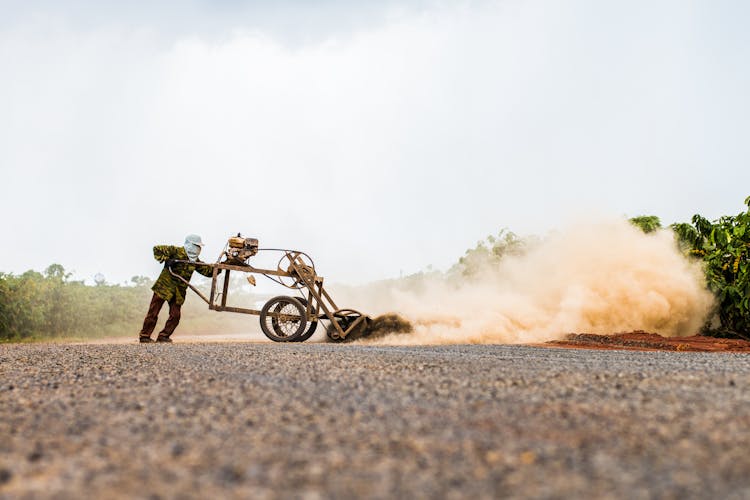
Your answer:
(169, 234), (371, 342)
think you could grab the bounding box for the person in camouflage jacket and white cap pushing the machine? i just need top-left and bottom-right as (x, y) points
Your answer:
(138, 234), (213, 343)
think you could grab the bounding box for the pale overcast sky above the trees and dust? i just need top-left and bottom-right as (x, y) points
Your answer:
(0, 0), (750, 283)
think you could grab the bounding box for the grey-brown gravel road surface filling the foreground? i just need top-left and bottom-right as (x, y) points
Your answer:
(0, 343), (750, 499)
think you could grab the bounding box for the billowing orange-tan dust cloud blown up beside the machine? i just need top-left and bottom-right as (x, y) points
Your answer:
(336, 219), (713, 344)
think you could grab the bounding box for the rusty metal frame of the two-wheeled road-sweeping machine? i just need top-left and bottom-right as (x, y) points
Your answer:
(167, 249), (367, 340)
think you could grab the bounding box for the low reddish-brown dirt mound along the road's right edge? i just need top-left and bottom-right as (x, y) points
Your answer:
(539, 331), (750, 352)
